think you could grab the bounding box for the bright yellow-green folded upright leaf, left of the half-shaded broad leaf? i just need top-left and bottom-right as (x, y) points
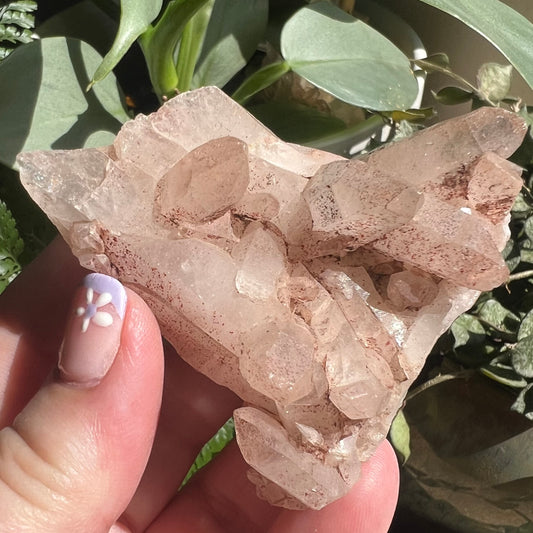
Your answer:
(139, 0), (208, 98)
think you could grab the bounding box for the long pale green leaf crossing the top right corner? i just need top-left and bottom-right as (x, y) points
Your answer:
(421, 0), (533, 88)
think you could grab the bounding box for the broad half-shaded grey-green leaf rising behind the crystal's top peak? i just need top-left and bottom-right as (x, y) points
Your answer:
(191, 0), (268, 89)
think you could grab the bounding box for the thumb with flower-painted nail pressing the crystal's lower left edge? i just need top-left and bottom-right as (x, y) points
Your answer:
(0, 274), (163, 533)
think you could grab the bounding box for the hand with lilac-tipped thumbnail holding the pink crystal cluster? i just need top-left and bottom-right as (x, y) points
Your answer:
(0, 240), (398, 533)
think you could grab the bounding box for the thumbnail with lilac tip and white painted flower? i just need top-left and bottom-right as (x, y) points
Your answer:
(59, 274), (127, 385)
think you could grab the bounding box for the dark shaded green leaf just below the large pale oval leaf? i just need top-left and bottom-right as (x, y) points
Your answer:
(248, 102), (346, 144)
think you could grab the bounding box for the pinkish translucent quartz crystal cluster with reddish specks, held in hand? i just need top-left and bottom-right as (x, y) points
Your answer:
(18, 87), (526, 509)
